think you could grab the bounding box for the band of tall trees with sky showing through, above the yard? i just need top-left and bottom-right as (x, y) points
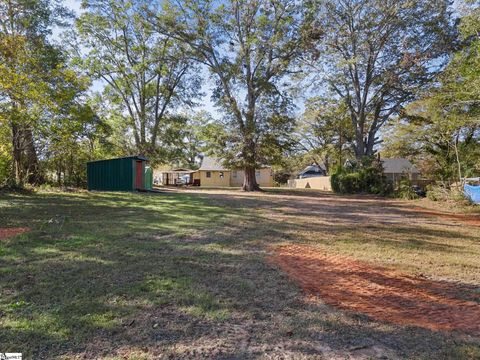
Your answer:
(0, 0), (480, 190)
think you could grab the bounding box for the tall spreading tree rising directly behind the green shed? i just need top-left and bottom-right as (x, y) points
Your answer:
(77, 0), (200, 161)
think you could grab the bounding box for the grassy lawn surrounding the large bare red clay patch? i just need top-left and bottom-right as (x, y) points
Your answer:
(0, 190), (480, 359)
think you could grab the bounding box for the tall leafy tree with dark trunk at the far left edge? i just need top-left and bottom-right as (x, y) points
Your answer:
(0, 0), (72, 185)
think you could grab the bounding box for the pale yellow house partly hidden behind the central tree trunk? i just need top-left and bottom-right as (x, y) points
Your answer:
(193, 156), (273, 187)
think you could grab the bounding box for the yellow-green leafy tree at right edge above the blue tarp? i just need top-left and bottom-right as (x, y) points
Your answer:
(383, 1), (480, 182)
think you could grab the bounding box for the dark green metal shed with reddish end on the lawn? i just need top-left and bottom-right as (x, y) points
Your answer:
(87, 156), (148, 191)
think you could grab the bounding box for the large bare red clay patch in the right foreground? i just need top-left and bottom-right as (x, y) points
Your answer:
(269, 245), (480, 335)
